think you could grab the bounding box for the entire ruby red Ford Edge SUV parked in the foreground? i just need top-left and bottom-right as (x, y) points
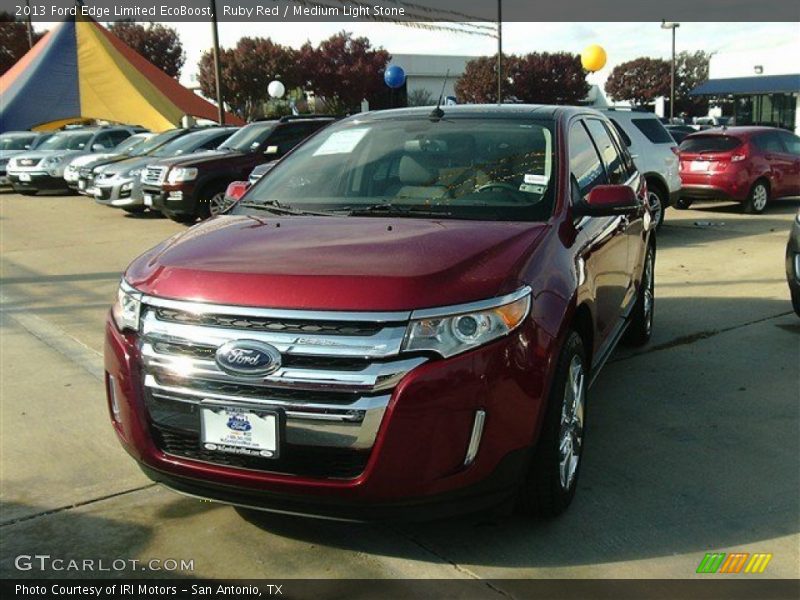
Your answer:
(105, 105), (655, 519)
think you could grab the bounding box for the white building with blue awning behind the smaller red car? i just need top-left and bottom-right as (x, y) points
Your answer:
(691, 42), (800, 133)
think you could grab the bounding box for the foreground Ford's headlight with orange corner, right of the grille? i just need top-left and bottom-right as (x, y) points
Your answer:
(403, 287), (531, 358)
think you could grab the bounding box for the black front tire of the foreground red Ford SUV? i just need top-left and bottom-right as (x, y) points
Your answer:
(515, 330), (589, 518)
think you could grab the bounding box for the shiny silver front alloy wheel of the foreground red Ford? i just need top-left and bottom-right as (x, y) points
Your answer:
(558, 355), (586, 491)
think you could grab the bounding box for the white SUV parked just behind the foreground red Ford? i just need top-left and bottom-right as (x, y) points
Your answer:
(600, 108), (681, 227)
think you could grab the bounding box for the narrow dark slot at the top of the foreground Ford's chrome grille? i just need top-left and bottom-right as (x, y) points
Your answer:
(156, 308), (381, 336)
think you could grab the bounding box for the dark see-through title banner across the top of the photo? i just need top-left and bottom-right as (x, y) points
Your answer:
(0, 0), (800, 25)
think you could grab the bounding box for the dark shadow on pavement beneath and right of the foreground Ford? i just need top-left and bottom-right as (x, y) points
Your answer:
(242, 298), (800, 576)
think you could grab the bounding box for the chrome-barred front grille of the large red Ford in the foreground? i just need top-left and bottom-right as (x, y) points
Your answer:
(140, 297), (427, 478)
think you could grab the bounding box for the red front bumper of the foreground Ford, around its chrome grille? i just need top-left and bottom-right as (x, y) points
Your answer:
(105, 312), (554, 520)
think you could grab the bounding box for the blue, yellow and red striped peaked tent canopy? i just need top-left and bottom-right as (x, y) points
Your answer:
(0, 18), (242, 132)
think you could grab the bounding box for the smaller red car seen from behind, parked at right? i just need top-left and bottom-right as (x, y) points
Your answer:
(676, 127), (800, 214)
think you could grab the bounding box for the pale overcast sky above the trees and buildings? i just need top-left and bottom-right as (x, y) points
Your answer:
(36, 21), (800, 86)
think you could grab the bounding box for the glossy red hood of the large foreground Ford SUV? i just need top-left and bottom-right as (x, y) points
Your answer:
(126, 215), (547, 311)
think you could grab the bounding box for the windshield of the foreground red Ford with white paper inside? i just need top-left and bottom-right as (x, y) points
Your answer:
(234, 117), (555, 221)
